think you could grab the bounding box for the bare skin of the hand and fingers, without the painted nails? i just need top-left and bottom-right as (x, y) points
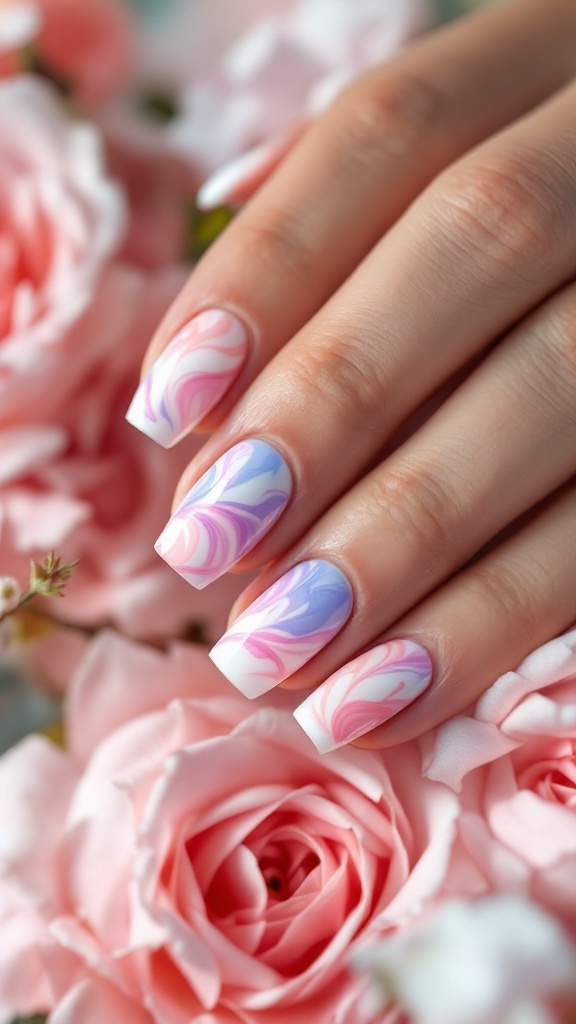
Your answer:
(138, 0), (576, 748)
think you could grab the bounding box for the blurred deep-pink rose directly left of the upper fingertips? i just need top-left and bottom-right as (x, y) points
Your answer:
(0, 264), (242, 653)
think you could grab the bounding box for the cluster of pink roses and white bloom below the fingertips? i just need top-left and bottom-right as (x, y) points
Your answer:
(0, 632), (576, 1024)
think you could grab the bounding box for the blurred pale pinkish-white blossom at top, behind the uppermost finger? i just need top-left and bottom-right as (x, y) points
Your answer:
(167, 0), (429, 172)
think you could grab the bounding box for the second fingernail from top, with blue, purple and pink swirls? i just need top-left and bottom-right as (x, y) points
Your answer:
(155, 439), (292, 590)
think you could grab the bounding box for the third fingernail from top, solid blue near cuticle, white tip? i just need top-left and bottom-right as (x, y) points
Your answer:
(210, 559), (353, 698)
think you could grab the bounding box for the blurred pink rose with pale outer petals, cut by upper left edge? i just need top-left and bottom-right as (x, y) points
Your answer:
(0, 77), (124, 423)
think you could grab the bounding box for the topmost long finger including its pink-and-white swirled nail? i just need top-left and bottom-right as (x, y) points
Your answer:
(128, 0), (576, 444)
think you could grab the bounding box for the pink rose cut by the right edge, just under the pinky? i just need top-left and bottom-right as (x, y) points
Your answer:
(425, 631), (576, 928)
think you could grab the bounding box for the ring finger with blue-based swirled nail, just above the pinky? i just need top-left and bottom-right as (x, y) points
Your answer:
(211, 285), (576, 697)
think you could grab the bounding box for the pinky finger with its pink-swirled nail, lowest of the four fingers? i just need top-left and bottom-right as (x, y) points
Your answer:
(294, 481), (576, 754)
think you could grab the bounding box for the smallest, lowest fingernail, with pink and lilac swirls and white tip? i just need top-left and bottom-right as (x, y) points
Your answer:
(294, 640), (433, 754)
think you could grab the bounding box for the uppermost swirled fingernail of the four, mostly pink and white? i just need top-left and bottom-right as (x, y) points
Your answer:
(126, 309), (248, 447)
